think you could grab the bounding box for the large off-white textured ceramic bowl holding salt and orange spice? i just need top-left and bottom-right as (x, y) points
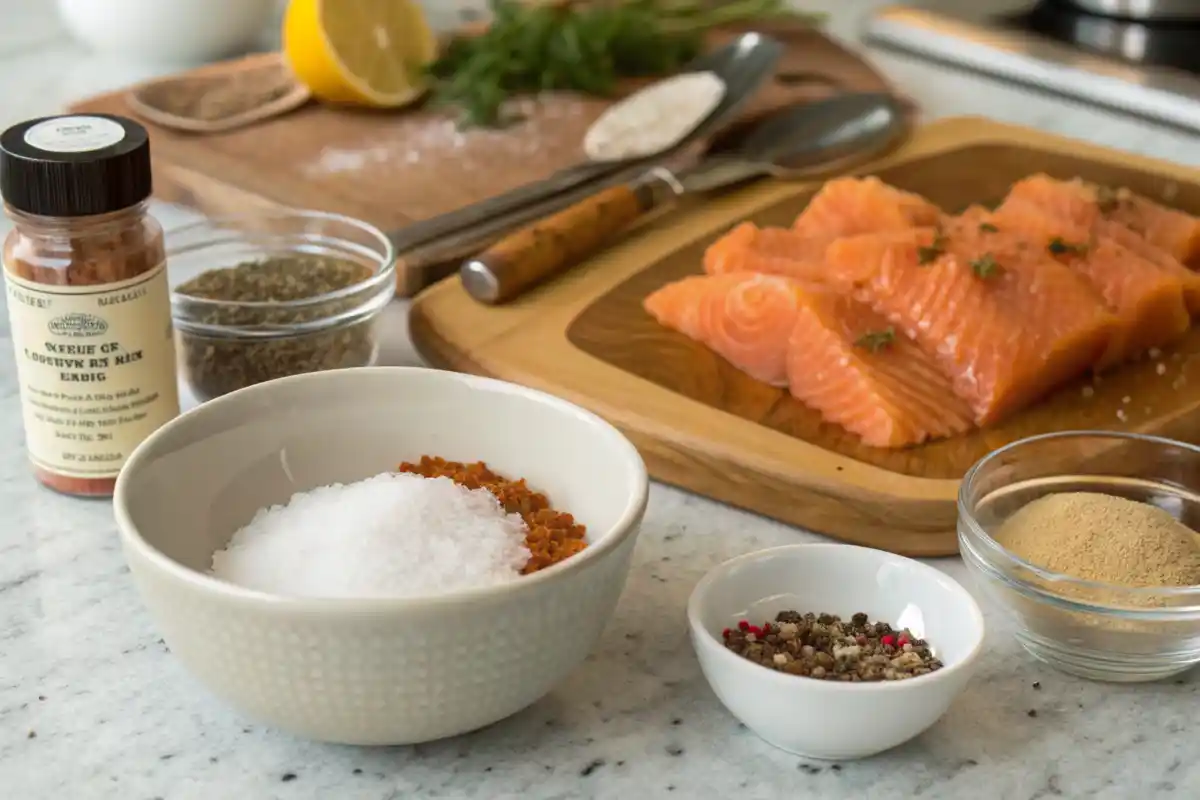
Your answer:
(114, 367), (648, 745)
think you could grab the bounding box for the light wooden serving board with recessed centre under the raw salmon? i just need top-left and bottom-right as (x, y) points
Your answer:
(410, 118), (1200, 555)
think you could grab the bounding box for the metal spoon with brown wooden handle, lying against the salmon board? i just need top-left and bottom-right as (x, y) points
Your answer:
(461, 94), (907, 305)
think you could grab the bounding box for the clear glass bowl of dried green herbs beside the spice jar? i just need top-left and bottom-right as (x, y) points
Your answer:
(167, 209), (396, 402)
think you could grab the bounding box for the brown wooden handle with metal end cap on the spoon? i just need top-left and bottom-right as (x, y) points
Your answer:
(462, 181), (659, 306)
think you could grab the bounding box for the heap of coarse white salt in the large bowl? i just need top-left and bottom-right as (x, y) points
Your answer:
(212, 473), (530, 599)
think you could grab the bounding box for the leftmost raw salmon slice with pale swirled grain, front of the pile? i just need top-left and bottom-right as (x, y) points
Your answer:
(643, 272), (804, 386)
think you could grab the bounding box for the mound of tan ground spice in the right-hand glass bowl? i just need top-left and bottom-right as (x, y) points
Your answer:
(995, 492), (1200, 588)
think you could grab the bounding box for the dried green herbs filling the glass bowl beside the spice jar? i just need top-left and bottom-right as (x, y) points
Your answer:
(175, 254), (376, 399)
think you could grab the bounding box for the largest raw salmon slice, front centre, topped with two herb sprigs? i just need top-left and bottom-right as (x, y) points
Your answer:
(826, 223), (1116, 425)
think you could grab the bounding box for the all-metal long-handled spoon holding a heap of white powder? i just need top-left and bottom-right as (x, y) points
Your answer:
(389, 34), (784, 255)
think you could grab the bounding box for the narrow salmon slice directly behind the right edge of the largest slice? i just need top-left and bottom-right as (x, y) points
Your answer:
(979, 199), (1192, 368)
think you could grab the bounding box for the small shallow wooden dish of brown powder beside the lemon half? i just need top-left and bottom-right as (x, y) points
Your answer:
(126, 53), (312, 133)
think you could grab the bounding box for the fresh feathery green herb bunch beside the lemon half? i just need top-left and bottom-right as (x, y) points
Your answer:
(430, 0), (812, 126)
